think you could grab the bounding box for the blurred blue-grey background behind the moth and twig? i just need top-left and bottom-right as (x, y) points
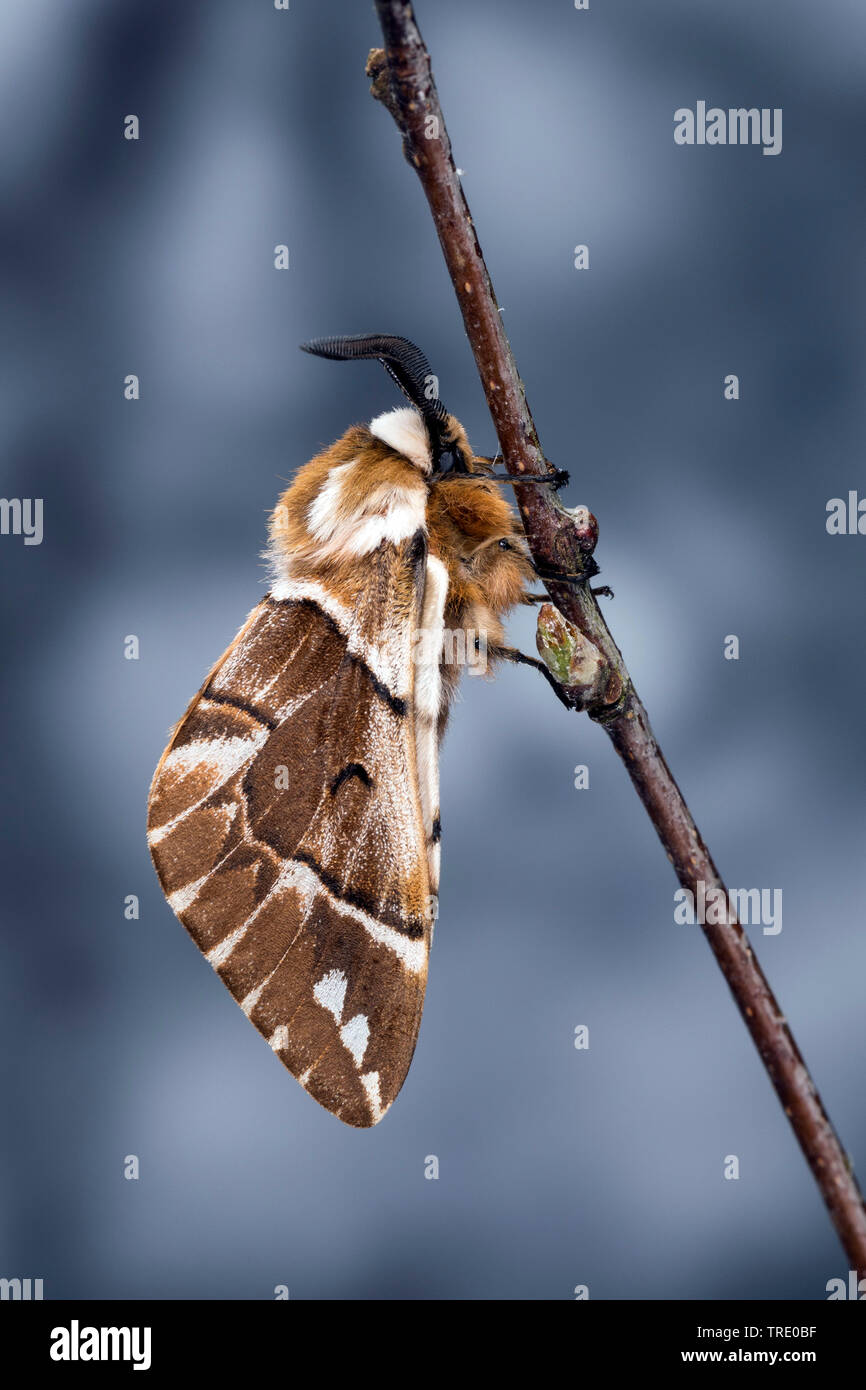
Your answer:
(0, 0), (866, 1300)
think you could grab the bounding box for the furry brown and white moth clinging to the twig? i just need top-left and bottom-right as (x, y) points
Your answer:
(147, 335), (561, 1126)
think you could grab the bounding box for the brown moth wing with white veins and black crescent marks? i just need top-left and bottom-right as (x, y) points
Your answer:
(149, 534), (438, 1126)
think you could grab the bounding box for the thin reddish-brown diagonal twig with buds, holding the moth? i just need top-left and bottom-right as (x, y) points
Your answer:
(367, 0), (866, 1277)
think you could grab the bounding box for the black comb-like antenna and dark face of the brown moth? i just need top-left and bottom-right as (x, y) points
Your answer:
(300, 334), (473, 477)
